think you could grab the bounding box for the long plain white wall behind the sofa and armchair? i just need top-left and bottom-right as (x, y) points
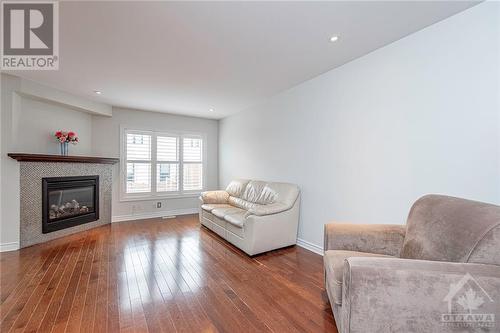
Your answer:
(219, 2), (500, 248)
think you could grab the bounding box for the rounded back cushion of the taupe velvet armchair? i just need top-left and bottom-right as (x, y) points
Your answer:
(400, 195), (500, 262)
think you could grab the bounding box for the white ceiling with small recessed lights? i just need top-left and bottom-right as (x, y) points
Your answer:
(7, 1), (475, 118)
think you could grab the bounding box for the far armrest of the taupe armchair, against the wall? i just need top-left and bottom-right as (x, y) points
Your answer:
(324, 223), (406, 256)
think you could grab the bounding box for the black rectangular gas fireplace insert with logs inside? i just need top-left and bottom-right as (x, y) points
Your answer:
(42, 176), (99, 234)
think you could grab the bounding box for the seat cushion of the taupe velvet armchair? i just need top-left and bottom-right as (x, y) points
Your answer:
(323, 250), (394, 305)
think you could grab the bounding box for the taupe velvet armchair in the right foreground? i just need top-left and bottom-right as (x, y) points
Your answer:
(324, 195), (500, 333)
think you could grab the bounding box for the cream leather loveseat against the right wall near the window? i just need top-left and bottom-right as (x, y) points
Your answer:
(200, 179), (300, 255)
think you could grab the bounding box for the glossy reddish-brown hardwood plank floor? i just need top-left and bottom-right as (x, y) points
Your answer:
(0, 215), (337, 332)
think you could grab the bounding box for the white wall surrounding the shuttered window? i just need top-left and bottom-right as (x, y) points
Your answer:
(92, 107), (219, 221)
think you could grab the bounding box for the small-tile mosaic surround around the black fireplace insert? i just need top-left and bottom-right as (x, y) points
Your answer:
(11, 156), (118, 248)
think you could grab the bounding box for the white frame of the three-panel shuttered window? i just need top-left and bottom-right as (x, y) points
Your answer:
(119, 126), (207, 201)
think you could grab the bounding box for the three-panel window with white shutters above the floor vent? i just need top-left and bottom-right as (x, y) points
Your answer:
(122, 130), (204, 198)
